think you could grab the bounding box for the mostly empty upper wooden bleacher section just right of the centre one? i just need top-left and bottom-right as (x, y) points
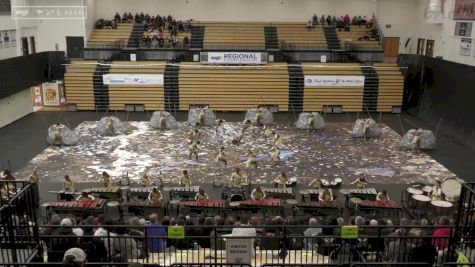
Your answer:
(272, 22), (328, 49)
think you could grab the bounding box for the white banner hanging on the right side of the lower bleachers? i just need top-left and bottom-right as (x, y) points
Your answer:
(305, 75), (364, 87)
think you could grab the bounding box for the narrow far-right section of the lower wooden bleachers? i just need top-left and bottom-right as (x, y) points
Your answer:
(374, 63), (404, 112)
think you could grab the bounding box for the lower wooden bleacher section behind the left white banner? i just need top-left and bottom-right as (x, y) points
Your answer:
(109, 61), (165, 110)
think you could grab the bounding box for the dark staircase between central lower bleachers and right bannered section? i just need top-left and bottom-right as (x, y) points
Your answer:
(287, 64), (304, 114)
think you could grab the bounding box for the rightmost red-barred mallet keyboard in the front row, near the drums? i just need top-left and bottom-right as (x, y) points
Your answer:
(357, 200), (401, 220)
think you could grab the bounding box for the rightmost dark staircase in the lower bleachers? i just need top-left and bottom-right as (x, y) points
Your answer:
(361, 66), (379, 112)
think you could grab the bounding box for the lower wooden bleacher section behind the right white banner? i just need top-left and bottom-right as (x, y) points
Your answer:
(302, 63), (364, 112)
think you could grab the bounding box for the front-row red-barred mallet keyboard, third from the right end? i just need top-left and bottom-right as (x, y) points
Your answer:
(229, 198), (284, 216)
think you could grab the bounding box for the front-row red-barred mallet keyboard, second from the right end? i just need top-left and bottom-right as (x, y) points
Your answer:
(293, 201), (342, 217)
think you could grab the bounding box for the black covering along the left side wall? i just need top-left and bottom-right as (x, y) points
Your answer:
(0, 52), (65, 98)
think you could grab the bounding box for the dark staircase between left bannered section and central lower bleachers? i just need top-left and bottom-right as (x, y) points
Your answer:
(163, 64), (180, 112)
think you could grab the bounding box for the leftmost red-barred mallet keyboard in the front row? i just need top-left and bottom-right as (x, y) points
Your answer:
(46, 199), (106, 217)
